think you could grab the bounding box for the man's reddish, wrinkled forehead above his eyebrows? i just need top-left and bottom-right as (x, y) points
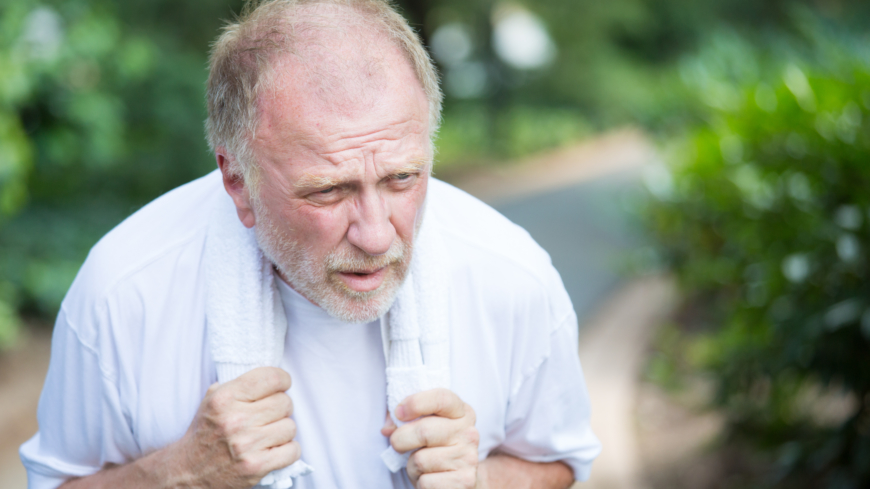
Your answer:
(256, 38), (428, 154)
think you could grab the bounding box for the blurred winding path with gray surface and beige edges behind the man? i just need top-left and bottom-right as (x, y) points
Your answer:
(455, 127), (675, 489)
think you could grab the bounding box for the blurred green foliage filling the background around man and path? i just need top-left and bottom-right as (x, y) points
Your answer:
(0, 0), (870, 488)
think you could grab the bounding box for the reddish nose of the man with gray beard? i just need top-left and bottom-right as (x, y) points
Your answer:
(347, 189), (396, 256)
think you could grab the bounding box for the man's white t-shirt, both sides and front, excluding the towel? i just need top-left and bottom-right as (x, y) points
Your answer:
(20, 172), (600, 489)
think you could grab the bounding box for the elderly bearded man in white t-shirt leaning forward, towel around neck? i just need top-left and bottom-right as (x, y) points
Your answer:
(21, 0), (599, 489)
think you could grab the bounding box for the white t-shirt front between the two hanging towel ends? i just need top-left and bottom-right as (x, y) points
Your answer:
(278, 280), (392, 489)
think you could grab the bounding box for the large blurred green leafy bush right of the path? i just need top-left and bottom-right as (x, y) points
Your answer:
(647, 16), (870, 488)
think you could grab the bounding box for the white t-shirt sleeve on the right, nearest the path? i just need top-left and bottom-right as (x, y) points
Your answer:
(499, 314), (601, 481)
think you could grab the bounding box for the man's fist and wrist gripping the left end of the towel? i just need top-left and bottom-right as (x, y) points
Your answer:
(172, 367), (300, 489)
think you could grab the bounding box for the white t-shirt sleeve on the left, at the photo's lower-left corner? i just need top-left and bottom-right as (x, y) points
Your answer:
(19, 309), (138, 489)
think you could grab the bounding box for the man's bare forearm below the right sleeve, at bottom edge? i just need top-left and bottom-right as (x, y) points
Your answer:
(478, 453), (574, 489)
